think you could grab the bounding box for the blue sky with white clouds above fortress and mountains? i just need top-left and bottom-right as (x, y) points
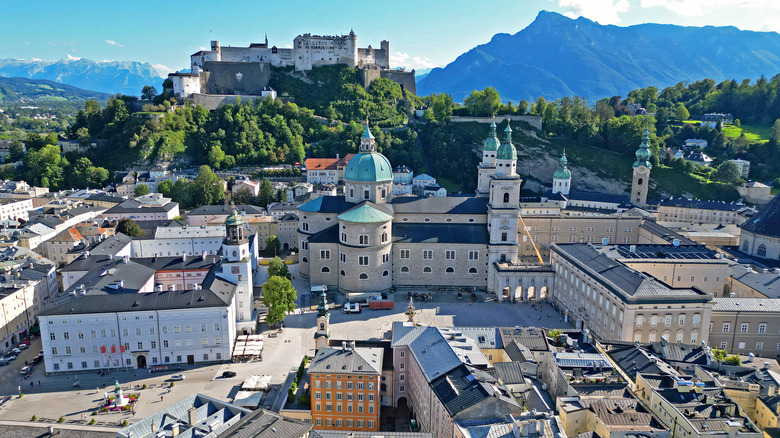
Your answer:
(0, 0), (780, 69)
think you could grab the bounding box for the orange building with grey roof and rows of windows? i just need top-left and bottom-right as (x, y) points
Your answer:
(308, 342), (383, 432)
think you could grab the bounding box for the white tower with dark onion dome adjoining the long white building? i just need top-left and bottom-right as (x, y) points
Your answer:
(219, 208), (255, 334)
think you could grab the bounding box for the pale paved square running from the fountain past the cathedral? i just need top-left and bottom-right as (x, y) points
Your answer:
(0, 266), (571, 426)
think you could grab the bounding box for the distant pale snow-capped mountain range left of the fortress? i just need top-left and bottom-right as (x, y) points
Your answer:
(0, 58), (168, 96)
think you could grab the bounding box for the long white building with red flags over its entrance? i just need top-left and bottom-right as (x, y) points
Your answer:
(39, 278), (236, 373)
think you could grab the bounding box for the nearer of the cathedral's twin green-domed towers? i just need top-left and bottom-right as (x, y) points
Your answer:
(488, 121), (523, 278)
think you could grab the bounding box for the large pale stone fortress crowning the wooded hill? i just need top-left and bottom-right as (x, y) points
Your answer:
(168, 31), (417, 106)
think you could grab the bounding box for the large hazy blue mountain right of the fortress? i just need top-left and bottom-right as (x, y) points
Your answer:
(417, 11), (780, 102)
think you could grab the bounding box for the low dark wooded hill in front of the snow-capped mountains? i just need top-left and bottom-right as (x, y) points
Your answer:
(0, 77), (110, 102)
